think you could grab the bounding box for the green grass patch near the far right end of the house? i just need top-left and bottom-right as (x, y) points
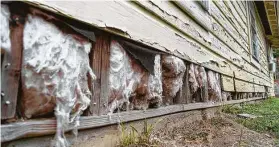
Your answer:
(222, 98), (279, 138)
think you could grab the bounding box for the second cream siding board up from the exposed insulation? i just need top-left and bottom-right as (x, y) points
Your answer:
(132, 1), (272, 87)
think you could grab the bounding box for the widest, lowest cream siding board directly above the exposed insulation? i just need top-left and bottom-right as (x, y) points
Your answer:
(24, 1), (270, 86)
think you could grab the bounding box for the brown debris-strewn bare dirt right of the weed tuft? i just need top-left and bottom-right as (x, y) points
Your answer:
(153, 116), (279, 147)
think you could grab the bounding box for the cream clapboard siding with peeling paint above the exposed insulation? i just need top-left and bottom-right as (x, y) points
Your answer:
(30, 1), (273, 94)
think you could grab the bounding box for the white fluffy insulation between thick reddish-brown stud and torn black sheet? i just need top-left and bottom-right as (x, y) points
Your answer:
(108, 41), (143, 114)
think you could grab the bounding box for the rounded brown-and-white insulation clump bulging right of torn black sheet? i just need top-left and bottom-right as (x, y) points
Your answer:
(162, 55), (186, 105)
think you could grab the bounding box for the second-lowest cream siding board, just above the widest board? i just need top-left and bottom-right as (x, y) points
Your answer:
(136, 1), (272, 89)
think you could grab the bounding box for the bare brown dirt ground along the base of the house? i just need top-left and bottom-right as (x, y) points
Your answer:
(70, 113), (279, 147)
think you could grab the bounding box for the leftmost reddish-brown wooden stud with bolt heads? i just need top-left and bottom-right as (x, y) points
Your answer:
(1, 14), (24, 119)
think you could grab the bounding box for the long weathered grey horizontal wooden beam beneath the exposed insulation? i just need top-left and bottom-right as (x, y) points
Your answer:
(1, 97), (263, 142)
